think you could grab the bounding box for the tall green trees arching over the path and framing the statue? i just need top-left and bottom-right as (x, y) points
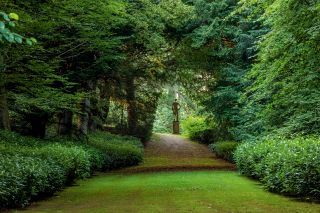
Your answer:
(0, 0), (320, 140)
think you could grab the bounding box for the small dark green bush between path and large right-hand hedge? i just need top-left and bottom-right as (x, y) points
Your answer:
(209, 141), (239, 162)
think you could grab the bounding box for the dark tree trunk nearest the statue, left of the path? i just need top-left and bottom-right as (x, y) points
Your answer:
(126, 77), (138, 135)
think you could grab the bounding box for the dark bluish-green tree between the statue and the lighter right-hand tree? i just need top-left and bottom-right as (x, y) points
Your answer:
(179, 0), (265, 140)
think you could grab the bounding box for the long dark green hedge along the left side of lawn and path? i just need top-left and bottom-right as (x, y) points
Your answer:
(0, 132), (143, 208)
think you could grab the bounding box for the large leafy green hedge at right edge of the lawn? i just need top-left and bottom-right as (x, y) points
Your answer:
(235, 138), (320, 199)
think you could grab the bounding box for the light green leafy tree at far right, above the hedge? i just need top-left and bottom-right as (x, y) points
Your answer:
(236, 0), (320, 138)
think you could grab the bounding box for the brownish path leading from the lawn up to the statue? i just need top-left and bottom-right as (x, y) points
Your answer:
(114, 134), (235, 173)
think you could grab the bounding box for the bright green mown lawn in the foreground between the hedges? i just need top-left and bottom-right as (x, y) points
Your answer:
(20, 171), (320, 213)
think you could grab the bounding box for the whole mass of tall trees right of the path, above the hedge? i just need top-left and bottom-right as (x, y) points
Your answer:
(179, 0), (320, 140)
